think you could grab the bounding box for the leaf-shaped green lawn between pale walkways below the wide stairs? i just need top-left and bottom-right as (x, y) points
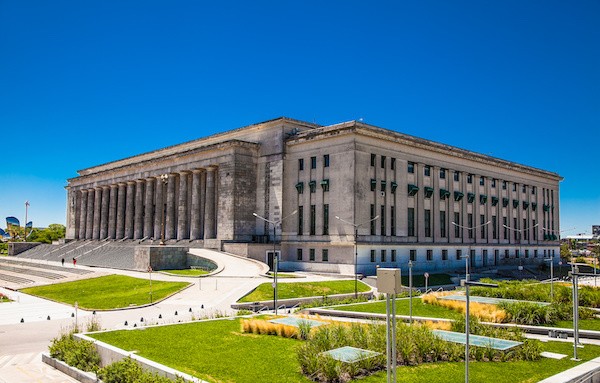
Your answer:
(21, 275), (189, 310)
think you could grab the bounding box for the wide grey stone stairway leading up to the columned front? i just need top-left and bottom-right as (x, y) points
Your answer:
(17, 240), (202, 270)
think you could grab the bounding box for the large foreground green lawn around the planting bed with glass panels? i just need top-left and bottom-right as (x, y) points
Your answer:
(91, 319), (600, 383)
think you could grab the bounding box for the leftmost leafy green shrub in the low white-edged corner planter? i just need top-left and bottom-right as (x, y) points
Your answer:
(49, 332), (100, 372)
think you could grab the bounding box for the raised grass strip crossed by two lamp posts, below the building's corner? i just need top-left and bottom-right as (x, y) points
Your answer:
(238, 280), (371, 302)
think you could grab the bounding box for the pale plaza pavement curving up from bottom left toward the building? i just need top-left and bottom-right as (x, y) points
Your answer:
(0, 249), (338, 383)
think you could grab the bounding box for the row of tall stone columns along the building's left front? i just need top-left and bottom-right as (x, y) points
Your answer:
(75, 167), (218, 240)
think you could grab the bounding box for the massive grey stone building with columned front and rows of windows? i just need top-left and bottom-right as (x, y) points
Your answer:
(67, 118), (561, 274)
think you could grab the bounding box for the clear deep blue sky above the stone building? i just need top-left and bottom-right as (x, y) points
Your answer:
(0, 0), (600, 234)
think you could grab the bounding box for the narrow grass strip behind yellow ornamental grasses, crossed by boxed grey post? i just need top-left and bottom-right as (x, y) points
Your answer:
(331, 298), (464, 319)
